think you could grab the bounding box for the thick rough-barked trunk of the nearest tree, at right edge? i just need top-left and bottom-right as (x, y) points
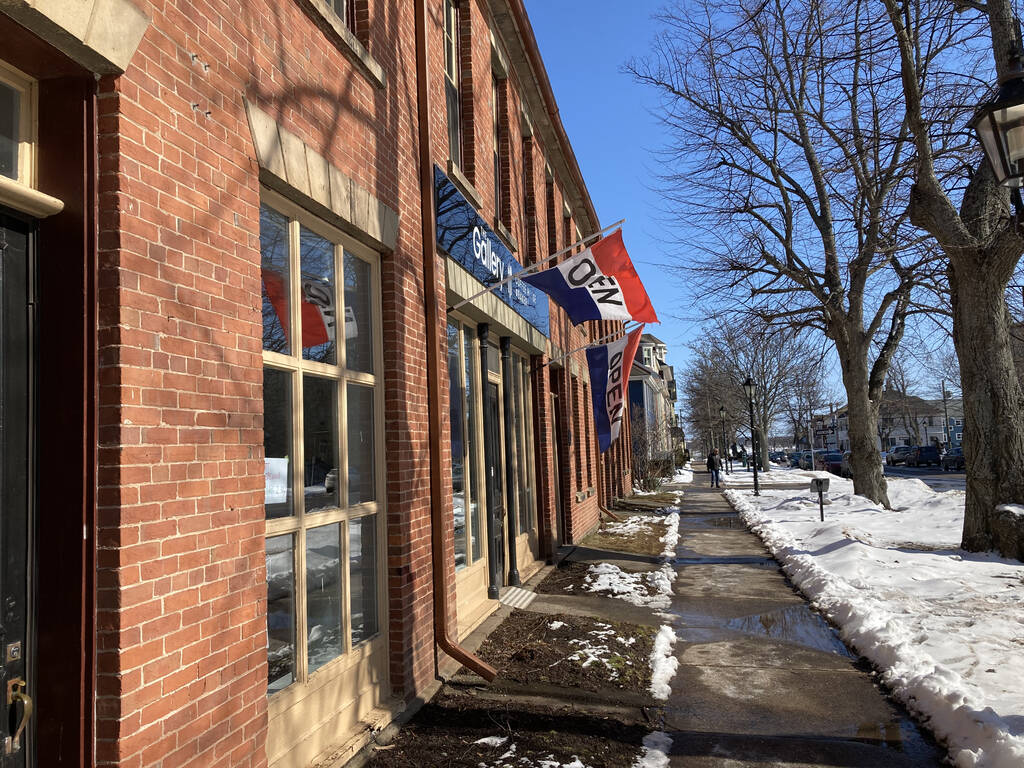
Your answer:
(948, 260), (1024, 559)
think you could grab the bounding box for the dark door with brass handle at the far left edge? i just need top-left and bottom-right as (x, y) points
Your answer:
(0, 207), (35, 768)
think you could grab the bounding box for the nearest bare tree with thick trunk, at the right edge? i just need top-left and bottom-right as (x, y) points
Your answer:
(883, 0), (1024, 556)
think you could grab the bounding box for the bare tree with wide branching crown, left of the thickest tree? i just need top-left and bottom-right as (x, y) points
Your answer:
(629, 0), (946, 505)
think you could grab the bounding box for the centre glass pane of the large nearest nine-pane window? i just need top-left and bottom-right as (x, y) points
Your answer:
(302, 375), (339, 512)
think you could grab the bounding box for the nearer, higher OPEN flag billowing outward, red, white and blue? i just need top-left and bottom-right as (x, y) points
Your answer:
(521, 229), (657, 326)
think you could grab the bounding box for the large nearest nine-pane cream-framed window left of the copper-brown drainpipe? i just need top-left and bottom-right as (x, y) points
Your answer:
(259, 190), (383, 694)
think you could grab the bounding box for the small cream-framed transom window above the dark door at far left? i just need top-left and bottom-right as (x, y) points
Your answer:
(0, 61), (36, 186)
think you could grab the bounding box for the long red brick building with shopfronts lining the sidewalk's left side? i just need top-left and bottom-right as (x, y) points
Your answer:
(0, 0), (631, 768)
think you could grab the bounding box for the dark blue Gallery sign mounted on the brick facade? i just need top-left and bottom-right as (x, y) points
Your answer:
(434, 166), (550, 336)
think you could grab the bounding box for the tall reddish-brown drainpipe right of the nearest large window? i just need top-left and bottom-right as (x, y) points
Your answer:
(416, 0), (498, 682)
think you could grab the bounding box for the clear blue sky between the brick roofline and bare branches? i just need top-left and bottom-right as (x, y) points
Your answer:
(526, 0), (698, 391)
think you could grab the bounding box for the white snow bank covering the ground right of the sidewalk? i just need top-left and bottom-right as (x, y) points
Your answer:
(726, 470), (1024, 768)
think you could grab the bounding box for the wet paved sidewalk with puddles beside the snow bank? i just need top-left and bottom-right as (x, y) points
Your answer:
(662, 483), (944, 768)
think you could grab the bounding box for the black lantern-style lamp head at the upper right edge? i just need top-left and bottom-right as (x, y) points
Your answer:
(968, 30), (1024, 190)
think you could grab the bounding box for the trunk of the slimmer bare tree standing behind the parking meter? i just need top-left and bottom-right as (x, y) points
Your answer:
(840, 349), (889, 509)
